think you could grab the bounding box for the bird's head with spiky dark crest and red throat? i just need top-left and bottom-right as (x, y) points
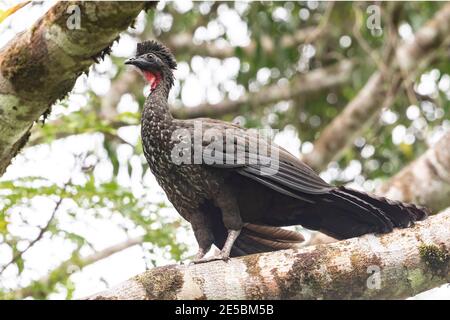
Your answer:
(125, 40), (177, 90)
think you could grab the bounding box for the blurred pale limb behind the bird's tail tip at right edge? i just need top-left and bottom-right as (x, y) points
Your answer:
(377, 131), (450, 212)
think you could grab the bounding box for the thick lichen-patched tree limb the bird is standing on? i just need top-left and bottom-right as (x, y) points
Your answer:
(88, 209), (450, 299)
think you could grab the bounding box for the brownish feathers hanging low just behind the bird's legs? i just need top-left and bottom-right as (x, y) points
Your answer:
(231, 224), (304, 257)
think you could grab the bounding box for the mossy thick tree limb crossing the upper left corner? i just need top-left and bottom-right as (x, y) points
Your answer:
(0, 2), (149, 175)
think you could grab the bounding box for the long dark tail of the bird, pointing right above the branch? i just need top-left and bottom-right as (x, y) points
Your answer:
(334, 187), (428, 232)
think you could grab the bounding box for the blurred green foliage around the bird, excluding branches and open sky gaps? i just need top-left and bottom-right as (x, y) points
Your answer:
(0, 1), (450, 299)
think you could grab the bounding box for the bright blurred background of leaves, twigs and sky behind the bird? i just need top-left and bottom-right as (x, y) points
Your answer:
(0, 1), (450, 298)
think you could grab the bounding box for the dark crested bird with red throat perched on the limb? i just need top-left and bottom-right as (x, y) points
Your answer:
(124, 40), (428, 263)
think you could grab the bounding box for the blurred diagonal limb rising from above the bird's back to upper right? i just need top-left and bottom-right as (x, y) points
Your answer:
(303, 4), (450, 170)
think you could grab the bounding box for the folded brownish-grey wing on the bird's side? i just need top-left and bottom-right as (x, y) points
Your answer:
(178, 119), (333, 202)
